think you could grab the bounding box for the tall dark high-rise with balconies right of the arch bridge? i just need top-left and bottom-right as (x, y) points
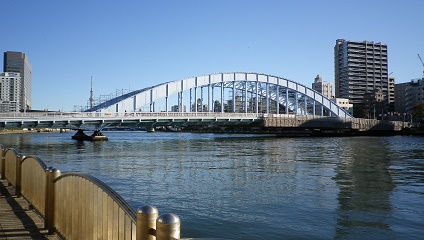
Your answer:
(334, 39), (394, 116)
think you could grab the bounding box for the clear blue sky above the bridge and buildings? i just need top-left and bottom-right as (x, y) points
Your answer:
(0, 0), (424, 111)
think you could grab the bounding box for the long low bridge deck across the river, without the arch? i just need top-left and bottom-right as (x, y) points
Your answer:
(0, 112), (409, 133)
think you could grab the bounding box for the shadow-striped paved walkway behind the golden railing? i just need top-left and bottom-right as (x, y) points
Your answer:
(0, 180), (60, 239)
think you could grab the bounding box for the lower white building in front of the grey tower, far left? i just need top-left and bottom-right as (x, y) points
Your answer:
(0, 72), (21, 112)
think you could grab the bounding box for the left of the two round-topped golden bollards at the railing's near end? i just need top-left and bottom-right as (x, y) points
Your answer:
(136, 205), (159, 240)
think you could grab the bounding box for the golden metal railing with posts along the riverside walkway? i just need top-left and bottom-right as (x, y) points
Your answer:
(0, 144), (180, 240)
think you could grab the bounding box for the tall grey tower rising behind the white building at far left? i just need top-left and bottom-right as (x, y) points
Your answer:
(3, 51), (32, 111)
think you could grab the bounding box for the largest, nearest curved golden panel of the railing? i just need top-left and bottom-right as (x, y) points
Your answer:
(52, 173), (136, 239)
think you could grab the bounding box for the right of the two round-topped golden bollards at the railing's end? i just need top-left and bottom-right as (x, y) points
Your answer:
(156, 213), (181, 240)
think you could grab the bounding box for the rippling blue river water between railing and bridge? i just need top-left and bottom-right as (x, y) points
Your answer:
(0, 132), (424, 239)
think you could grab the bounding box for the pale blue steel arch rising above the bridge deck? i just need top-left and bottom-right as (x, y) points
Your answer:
(87, 72), (351, 117)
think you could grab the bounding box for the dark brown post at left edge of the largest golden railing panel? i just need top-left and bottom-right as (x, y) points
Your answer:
(44, 167), (61, 234)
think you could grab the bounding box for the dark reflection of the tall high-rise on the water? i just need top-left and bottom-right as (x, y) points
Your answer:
(333, 138), (395, 239)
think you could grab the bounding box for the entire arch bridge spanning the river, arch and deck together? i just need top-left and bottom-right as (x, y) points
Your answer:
(0, 73), (407, 136)
